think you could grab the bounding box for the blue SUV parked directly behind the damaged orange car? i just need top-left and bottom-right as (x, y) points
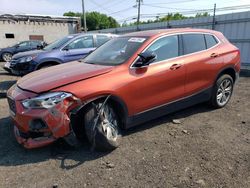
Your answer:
(4, 34), (117, 75)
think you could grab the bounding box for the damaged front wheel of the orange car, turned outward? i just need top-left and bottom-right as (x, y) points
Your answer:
(84, 102), (121, 151)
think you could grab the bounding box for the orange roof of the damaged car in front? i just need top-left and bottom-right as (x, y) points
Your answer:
(123, 28), (220, 37)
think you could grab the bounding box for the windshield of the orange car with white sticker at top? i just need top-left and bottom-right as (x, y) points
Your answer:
(83, 37), (147, 66)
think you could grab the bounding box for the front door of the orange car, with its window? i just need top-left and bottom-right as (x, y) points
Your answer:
(127, 35), (185, 113)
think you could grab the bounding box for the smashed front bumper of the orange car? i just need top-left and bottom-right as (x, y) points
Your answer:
(7, 87), (79, 149)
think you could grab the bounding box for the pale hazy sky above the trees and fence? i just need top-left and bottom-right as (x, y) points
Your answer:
(0, 0), (250, 23)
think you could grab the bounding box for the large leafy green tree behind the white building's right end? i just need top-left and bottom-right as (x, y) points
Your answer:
(63, 11), (119, 31)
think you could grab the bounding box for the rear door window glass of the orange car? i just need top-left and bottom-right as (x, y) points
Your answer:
(182, 34), (206, 54)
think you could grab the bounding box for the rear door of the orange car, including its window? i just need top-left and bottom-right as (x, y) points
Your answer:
(181, 33), (223, 96)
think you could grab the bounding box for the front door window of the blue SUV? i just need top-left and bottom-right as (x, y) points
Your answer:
(67, 36), (94, 50)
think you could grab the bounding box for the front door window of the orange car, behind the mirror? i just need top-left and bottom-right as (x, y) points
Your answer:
(147, 35), (179, 62)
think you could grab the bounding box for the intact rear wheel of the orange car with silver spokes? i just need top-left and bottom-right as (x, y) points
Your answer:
(209, 74), (234, 108)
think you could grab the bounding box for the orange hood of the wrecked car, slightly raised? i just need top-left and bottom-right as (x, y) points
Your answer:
(17, 61), (114, 93)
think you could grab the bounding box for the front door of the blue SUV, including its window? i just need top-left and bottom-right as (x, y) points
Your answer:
(62, 36), (95, 62)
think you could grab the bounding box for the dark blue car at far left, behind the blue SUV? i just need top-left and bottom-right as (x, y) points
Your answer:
(0, 40), (46, 62)
